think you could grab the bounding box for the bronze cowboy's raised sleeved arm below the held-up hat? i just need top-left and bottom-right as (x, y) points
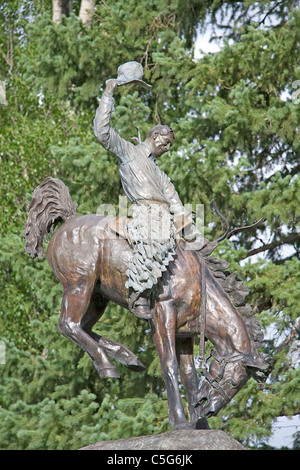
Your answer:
(94, 80), (133, 163)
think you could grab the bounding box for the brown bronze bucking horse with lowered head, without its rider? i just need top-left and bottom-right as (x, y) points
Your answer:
(24, 177), (267, 430)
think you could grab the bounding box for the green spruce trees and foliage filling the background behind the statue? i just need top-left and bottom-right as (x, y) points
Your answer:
(0, 0), (300, 449)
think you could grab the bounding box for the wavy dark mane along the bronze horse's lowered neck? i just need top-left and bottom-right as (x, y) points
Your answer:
(199, 241), (268, 380)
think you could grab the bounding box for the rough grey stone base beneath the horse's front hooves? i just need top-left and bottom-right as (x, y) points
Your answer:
(80, 429), (246, 451)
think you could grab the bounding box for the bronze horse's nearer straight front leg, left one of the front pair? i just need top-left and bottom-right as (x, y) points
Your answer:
(150, 301), (191, 430)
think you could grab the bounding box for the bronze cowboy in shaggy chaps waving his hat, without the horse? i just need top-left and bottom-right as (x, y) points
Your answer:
(94, 62), (201, 319)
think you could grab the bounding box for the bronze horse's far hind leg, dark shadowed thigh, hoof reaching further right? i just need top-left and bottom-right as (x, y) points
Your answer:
(81, 288), (146, 372)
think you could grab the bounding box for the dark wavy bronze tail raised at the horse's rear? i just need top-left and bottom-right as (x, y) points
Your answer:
(23, 177), (77, 259)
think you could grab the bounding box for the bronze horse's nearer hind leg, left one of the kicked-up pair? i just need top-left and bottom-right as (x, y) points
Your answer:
(58, 280), (119, 377)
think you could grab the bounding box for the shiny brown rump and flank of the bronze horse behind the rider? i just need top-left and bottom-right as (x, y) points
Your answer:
(47, 214), (131, 306)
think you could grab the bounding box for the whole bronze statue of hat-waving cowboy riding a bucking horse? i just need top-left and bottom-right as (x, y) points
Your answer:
(24, 64), (267, 429)
